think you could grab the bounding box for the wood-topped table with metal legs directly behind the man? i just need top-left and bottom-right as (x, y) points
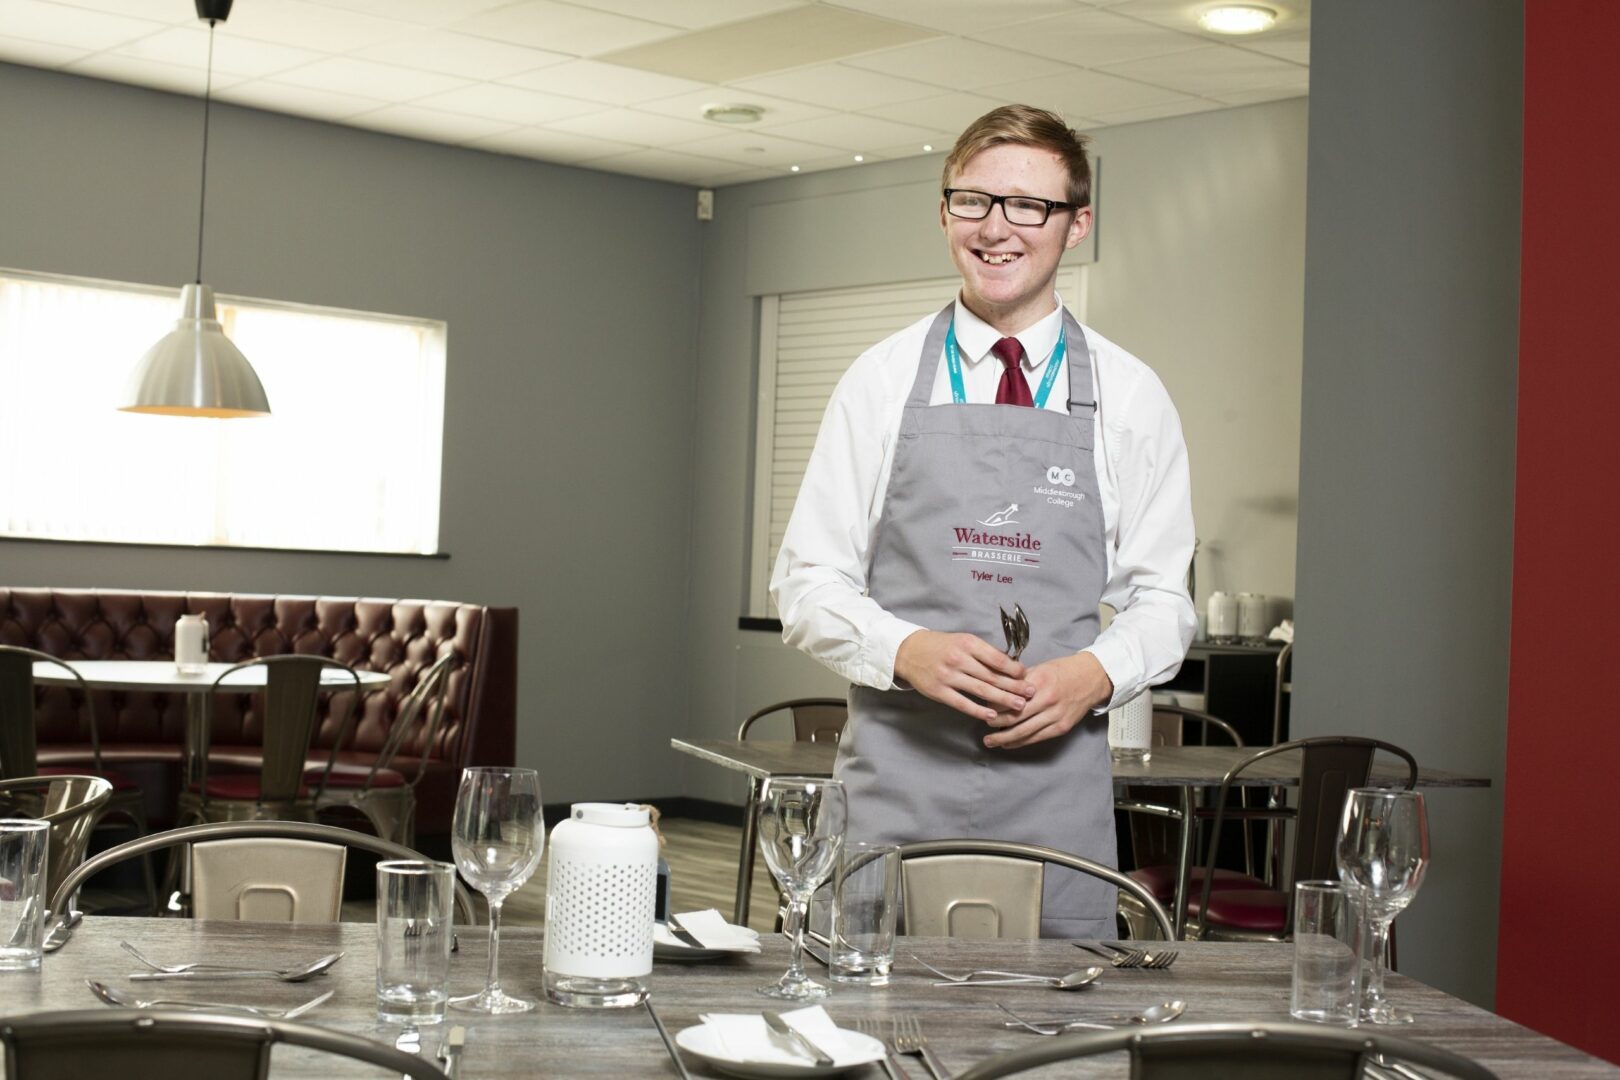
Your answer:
(669, 738), (1490, 938)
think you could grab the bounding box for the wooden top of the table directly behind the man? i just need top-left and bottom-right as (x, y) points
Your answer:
(669, 738), (1490, 787)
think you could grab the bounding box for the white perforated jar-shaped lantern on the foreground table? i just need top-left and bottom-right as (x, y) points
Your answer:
(546, 803), (658, 1009)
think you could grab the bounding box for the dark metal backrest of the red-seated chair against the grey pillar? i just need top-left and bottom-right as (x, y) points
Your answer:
(1200, 735), (1418, 910)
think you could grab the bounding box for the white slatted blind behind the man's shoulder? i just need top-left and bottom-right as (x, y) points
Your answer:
(748, 266), (1085, 619)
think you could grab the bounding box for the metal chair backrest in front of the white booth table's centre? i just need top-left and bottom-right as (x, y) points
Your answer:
(203, 653), (360, 803)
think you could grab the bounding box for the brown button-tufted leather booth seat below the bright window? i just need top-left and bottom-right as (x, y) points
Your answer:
(0, 586), (517, 837)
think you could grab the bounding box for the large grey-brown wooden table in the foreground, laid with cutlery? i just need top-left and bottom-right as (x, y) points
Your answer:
(15, 915), (1620, 1080)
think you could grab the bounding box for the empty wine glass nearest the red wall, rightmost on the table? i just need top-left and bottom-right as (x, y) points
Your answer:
(1338, 787), (1429, 1023)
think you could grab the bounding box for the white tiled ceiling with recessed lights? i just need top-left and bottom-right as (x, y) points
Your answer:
(0, 0), (1311, 186)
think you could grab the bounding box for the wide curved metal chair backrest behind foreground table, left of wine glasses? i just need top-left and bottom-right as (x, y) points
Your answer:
(52, 821), (478, 941)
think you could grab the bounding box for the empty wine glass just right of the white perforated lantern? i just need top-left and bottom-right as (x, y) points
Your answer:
(758, 776), (849, 1001)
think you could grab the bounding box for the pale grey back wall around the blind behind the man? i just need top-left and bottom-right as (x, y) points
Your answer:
(682, 99), (1306, 801)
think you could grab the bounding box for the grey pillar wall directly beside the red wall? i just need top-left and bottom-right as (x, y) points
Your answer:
(1293, 0), (1524, 1006)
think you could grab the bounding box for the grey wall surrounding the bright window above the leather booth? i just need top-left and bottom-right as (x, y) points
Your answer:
(0, 65), (700, 801)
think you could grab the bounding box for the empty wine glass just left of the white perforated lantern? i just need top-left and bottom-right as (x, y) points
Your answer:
(450, 767), (546, 1012)
